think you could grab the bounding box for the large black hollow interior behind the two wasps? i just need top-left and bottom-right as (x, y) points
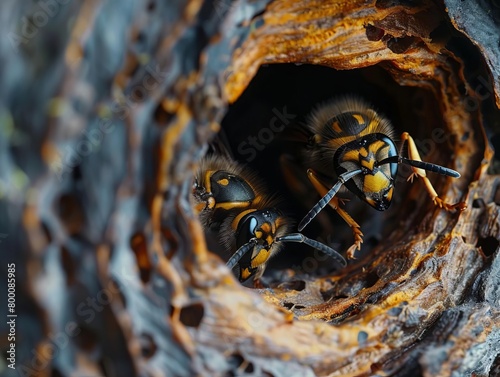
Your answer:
(211, 64), (449, 274)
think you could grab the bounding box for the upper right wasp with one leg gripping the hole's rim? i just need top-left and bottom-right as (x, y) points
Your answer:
(298, 97), (467, 259)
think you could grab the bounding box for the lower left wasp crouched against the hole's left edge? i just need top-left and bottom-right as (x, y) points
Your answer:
(192, 155), (346, 282)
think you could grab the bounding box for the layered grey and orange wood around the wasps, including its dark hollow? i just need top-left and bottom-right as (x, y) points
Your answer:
(0, 0), (500, 376)
